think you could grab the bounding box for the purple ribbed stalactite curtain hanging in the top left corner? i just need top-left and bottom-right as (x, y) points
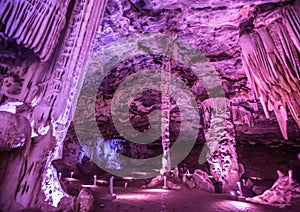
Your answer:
(0, 0), (70, 61)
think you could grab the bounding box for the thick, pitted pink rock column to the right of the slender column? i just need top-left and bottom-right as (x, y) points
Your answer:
(201, 97), (243, 190)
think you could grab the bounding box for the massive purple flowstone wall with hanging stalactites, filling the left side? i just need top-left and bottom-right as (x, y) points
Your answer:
(0, 0), (106, 211)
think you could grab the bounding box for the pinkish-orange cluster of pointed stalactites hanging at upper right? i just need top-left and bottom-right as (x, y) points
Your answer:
(240, 5), (300, 139)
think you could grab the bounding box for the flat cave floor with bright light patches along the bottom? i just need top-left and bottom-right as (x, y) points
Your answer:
(93, 187), (300, 212)
